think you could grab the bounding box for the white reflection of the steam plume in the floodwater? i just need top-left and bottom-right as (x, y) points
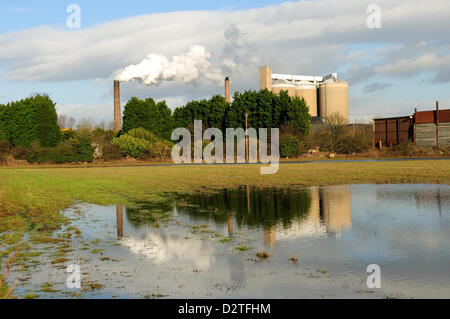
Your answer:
(120, 232), (214, 268)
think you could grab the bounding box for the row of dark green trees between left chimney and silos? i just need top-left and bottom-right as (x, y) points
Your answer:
(122, 90), (311, 139)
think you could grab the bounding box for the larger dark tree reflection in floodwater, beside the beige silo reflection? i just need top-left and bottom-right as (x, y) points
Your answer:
(177, 187), (311, 227)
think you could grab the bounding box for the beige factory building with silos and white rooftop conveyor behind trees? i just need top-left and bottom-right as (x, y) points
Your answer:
(260, 66), (349, 121)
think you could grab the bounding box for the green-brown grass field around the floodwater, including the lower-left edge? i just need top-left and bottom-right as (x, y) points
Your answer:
(0, 159), (450, 298)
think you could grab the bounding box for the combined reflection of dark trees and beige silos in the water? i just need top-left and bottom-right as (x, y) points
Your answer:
(175, 186), (352, 246)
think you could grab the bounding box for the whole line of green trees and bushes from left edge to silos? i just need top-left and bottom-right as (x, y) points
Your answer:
(0, 90), (310, 163)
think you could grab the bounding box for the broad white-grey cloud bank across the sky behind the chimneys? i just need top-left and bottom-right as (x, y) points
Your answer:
(0, 0), (450, 121)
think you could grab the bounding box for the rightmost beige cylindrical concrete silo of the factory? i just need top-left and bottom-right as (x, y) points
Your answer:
(319, 78), (349, 121)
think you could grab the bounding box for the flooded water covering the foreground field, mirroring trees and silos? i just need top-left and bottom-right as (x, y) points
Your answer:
(13, 185), (450, 298)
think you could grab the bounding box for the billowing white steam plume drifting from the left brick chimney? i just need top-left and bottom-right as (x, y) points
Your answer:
(115, 45), (224, 85)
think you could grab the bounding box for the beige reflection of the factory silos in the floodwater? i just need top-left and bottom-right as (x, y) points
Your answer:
(264, 186), (352, 246)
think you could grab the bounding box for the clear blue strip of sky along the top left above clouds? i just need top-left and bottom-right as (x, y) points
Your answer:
(0, 0), (284, 32)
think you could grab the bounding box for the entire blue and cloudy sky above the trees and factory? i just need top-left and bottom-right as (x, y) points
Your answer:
(0, 0), (450, 126)
